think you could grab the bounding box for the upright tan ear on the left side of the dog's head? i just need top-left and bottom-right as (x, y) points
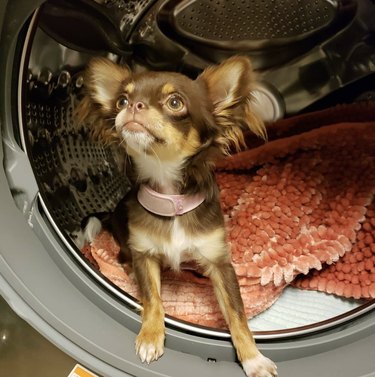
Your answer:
(85, 58), (131, 111)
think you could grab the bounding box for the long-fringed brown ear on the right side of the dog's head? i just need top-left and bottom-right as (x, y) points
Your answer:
(197, 56), (266, 153)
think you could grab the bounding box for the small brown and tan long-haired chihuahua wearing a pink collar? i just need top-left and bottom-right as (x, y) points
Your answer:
(77, 56), (277, 377)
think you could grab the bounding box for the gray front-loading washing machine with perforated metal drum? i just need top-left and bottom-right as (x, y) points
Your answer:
(0, 0), (375, 377)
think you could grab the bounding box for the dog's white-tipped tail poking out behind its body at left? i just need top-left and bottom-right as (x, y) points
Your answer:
(71, 212), (111, 249)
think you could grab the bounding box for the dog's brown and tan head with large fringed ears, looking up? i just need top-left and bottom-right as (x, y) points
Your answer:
(78, 56), (265, 160)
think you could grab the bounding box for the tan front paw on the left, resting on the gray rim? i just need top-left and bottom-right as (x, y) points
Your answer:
(135, 329), (164, 364)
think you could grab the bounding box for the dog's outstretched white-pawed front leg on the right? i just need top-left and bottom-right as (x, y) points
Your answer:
(206, 260), (277, 377)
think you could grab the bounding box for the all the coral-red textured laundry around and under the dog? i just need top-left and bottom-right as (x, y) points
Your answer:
(83, 104), (375, 327)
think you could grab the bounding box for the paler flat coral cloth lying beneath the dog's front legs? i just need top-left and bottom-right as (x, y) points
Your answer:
(83, 231), (284, 328)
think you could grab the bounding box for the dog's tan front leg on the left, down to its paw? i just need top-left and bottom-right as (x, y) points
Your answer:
(133, 252), (165, 364)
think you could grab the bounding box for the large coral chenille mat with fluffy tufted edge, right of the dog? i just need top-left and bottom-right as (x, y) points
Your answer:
(218, 123), (375, 286)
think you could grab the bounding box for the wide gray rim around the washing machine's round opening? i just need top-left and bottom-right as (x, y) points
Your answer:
(0, 0), (375, 377)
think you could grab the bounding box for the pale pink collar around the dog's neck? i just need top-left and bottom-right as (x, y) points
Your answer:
(137, 185), (204, 216)
